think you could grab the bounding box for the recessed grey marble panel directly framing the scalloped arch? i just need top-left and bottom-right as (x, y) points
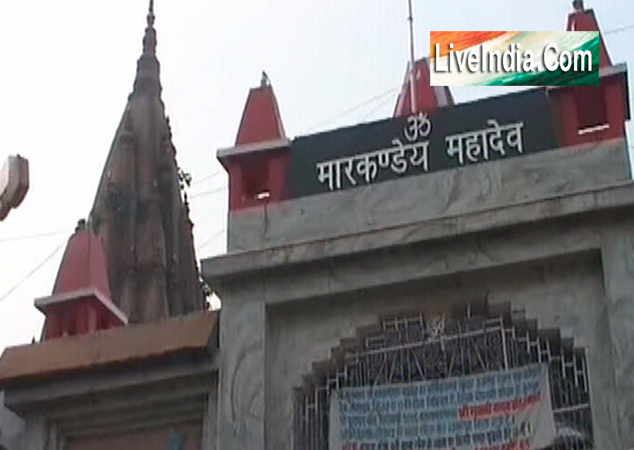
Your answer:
(265, 254), (621, 450)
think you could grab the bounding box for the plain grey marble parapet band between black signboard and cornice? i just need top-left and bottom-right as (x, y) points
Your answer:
(227, 139), (631, 253)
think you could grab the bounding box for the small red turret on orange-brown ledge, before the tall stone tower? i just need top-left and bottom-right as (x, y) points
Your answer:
(35, 220), (127, 340)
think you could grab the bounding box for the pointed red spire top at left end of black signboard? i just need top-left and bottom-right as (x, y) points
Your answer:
(236, 72), (286, 146)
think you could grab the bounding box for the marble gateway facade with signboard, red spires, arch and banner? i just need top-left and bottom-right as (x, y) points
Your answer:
(202, 2), (634, 450)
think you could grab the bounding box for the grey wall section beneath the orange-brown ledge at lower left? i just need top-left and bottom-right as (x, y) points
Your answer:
(0, 370), (218, 450)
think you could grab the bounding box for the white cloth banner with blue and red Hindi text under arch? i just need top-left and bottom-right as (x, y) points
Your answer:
(330, 364), (556, 450)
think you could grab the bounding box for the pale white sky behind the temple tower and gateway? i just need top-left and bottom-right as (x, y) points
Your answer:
(0, 0), (634, 349)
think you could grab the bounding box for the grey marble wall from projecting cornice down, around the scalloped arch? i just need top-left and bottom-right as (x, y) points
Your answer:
(209, 183), (634, 450)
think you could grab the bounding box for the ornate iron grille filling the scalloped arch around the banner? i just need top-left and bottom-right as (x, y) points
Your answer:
(294, 310), (593, 450)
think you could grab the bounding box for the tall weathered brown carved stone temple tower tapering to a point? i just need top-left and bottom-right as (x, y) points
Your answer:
(90, 1), (204, 323)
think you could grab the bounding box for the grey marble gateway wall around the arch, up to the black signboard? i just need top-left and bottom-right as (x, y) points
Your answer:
(202, 140), (634, 450)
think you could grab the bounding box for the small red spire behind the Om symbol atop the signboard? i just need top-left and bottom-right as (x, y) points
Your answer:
(394, 58), (454, 117)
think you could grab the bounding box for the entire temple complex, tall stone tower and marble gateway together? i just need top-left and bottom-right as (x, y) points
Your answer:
(0, 1), (634, 450)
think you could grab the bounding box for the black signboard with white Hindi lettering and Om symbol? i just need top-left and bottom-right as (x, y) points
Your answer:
(287, 89), (558, 197)
